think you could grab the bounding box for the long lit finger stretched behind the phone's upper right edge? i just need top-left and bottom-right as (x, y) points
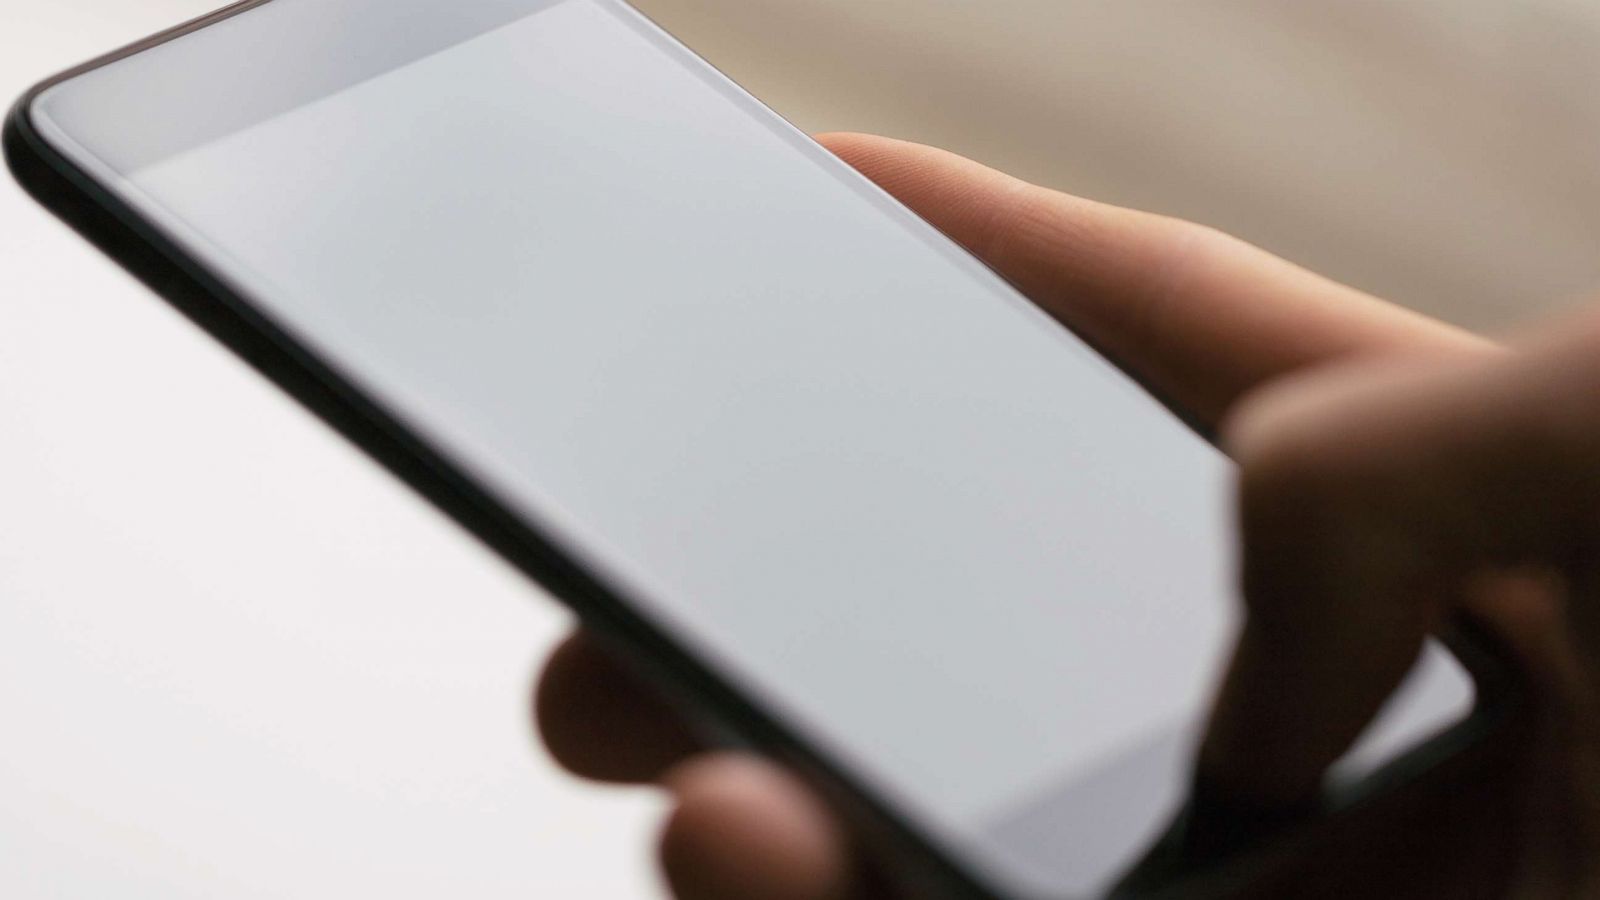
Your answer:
(819, 135), (1483, 424)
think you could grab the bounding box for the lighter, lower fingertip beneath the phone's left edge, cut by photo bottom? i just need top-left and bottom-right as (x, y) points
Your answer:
(661, 754), (856, 900)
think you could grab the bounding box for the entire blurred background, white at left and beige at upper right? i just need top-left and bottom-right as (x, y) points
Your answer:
(0, 0), (1600, 898)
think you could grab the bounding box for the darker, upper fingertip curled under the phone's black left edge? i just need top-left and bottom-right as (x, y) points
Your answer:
(534, 633), (701, 783)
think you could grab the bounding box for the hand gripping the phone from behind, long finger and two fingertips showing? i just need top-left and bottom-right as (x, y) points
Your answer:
(538, 135), (1536, 900)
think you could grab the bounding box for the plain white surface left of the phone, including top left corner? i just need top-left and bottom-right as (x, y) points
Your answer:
(0, 2), (654, 898)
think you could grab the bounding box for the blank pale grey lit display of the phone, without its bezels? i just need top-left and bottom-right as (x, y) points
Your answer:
(31, 0), (1465, 890)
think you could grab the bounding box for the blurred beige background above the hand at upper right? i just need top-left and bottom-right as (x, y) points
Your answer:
(638, 0), (1600, 328)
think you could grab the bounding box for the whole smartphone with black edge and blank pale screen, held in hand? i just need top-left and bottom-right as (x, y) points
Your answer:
(5, 0), (1510, 898)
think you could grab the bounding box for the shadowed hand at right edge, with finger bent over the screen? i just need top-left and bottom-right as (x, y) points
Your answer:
(1197, 296), (1600, 900)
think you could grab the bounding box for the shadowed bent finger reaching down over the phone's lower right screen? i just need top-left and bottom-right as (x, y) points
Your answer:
(1200, 315), (1600, 807)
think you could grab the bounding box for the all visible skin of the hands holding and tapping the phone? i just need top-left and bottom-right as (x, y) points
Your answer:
(534, 135), (1600, 900)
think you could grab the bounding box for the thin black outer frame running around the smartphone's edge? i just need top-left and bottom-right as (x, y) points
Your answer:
(0, 0), (1517, 898)
